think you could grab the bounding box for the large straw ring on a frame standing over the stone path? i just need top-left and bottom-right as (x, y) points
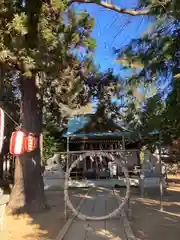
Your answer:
(64, 150), (130, 221)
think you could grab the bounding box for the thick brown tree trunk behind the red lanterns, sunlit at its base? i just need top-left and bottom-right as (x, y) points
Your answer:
(8, 77), (46, 212)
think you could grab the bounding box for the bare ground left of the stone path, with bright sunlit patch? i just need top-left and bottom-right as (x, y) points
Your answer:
(0, 189), (87, 240)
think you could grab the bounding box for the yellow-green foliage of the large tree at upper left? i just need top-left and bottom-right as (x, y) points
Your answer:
(0, 0), (96, 135)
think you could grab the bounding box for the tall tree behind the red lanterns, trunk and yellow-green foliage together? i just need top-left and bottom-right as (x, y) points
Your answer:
(0, 0), (95, 211)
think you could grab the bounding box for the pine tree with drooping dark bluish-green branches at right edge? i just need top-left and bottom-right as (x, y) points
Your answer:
(114, 2), (180, 141)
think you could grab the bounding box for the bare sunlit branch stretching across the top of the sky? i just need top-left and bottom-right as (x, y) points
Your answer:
(68, 0), (151, 16)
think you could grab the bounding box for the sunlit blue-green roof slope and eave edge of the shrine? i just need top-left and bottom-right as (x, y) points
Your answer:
(64, 114), (126, 137)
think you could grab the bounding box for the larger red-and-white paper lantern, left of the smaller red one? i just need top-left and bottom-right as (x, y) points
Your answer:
(10, 130), (26, 156)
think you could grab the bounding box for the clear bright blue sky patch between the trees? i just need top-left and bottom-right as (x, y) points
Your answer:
(77, 0), (150, 76)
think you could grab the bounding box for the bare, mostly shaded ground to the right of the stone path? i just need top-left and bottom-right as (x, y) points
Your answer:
(131, 177), (180, 240)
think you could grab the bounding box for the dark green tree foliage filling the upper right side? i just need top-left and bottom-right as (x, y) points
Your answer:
(116, 1), (180, 144)
